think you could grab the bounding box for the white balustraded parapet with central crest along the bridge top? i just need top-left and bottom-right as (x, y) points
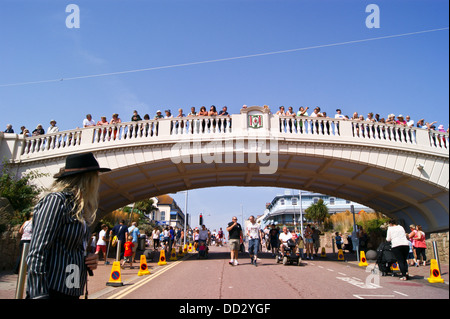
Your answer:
(0, 107), (449, 163)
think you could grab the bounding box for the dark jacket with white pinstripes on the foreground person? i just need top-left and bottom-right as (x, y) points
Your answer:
(27, 192), (89, 298)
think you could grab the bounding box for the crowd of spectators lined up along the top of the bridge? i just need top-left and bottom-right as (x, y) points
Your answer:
(4, 105), (449, 137)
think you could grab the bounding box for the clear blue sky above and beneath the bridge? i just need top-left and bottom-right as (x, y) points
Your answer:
(0, 0), (449, 232)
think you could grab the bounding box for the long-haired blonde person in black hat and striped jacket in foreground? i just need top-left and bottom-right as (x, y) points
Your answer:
(27, 153), (110, 299)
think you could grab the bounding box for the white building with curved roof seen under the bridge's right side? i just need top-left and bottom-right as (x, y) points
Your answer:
(260, 190), (374, 224)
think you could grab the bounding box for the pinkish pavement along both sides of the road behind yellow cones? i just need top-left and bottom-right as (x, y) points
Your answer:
(0, 248), (449, 299)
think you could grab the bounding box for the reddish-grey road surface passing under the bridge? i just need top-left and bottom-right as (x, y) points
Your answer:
(91, 247), (449, 300)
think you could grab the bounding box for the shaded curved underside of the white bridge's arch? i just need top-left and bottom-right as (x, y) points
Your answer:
(96, 146), (449, 232)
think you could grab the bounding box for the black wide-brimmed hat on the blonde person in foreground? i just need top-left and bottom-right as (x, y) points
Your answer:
(53, 153), (111, 178)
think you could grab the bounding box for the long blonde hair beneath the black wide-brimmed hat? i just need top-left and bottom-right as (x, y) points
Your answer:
(49, 171), (100, 225)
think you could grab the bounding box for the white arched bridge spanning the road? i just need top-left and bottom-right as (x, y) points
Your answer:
(0, 106), (449, 232)
